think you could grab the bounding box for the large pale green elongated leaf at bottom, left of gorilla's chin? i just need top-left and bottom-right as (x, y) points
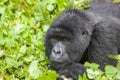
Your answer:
(29, 61), (40, 79)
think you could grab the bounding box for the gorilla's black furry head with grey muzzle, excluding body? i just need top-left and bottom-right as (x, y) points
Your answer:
(45, 9), (93, 68)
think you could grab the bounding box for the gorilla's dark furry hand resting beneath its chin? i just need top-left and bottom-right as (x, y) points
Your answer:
(58, 63), (86, 80)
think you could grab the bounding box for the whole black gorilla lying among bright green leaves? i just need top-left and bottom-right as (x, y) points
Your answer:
(45, 2), (120, 80)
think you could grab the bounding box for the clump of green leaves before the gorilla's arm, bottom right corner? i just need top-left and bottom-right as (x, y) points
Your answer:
(80, 62), (120, 80)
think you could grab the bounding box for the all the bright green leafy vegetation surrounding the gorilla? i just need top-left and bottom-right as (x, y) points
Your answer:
(0, 0), (120, 80)
